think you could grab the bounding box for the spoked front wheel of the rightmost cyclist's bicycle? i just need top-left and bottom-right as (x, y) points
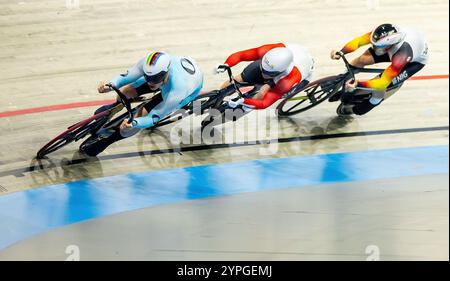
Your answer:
(277, 76), (341, 117)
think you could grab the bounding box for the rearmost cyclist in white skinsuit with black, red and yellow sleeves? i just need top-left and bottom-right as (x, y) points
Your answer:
(331, 24), (428, 115)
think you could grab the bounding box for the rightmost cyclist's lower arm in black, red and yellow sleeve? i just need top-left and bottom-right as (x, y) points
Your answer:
(358, 44), (413, 90)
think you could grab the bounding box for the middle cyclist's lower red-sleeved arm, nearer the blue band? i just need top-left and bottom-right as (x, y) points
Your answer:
(244, 67), (302, 109)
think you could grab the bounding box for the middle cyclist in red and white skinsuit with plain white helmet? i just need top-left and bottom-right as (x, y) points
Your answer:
(216, 43), (314, 110)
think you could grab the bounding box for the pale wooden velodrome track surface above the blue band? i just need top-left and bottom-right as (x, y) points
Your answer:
(0, 0), (449, 259)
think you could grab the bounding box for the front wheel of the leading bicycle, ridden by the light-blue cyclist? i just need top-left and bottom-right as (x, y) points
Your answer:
(36, 111), (109, 159)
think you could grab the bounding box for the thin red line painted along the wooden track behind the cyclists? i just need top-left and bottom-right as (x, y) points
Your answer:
(0, 74), (449, 118)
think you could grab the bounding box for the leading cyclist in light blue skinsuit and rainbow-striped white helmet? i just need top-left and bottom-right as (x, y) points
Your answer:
(80, 52), (203, 156)
